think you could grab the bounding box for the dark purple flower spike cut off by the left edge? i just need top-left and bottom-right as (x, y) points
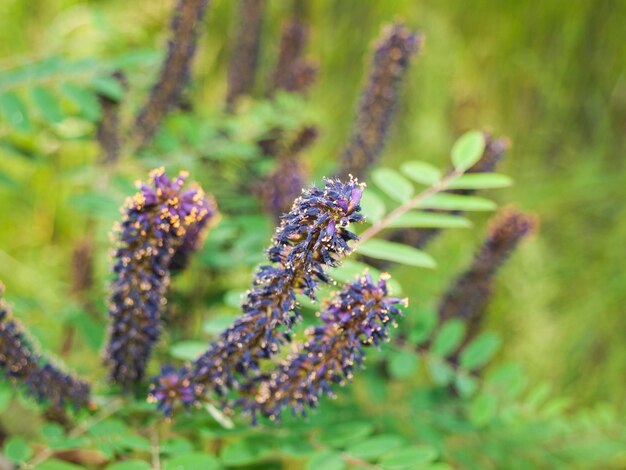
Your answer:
(0, 285), (90, 410)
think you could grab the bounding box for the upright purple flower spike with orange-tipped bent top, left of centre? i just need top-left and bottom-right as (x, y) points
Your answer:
(105, 168), (216, 388)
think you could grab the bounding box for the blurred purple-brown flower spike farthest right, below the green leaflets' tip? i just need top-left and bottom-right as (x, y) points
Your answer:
(439, 207), (537, 337)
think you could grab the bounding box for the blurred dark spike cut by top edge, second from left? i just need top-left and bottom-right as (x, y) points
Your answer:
(226, 0), (265, 109)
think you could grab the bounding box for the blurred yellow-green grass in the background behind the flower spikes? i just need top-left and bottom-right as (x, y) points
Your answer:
(0, 0), (626, 404)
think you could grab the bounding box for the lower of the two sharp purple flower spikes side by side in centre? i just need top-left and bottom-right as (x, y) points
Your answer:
(241, 274), (406, 421)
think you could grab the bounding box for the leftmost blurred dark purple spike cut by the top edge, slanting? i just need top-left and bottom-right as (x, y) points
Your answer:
(135, 0), (209, 146)
